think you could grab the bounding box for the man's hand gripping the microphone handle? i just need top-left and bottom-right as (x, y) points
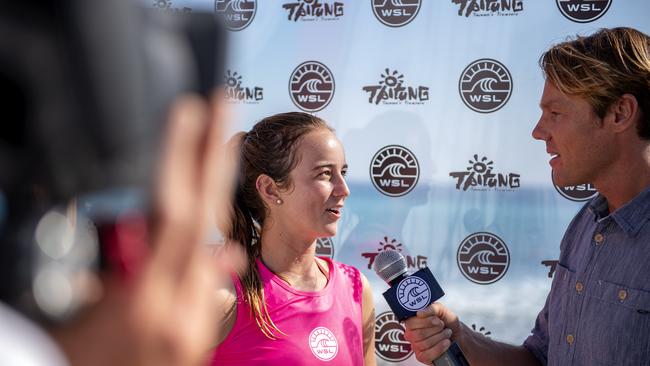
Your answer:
(404, 302), (462, 365)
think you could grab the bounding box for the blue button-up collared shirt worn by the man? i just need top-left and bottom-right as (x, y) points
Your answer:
(524, 188), (650, 366)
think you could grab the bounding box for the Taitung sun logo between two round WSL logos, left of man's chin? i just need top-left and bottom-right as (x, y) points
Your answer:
(449, 154), (521, 191)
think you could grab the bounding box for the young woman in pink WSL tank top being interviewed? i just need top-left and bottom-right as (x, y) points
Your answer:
(212, 112), (376, 366)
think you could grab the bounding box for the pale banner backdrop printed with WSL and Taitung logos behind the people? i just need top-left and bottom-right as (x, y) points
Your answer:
(153, 0), (650, 365)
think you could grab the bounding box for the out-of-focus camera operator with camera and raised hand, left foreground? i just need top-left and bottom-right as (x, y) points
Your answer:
(0, 0), (236, 365)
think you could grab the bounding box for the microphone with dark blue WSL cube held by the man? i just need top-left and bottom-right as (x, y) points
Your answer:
(373, 250), (469, 366)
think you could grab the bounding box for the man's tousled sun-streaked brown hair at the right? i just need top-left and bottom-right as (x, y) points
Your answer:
(539, 28), (650, 140)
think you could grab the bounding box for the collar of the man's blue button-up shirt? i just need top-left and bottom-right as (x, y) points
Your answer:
(589, 187), (650, 236)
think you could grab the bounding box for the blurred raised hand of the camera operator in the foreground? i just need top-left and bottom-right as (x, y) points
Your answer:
(53, 96), (241, 366)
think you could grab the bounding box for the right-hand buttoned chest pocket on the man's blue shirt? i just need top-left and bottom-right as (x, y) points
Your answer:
(580, 280), (650, 365)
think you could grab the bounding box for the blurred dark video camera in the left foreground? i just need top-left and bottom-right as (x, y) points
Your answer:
(0, 0), (226, 319)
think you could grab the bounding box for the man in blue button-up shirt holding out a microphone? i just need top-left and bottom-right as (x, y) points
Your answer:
(405, 28), (650, 366)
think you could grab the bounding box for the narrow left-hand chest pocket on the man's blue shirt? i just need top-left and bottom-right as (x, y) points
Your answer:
(548, 263), (576, 344)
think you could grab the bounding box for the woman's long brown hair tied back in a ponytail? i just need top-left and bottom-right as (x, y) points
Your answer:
(229, 112), (332, 339)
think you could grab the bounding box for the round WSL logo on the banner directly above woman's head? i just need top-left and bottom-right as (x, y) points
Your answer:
(289, 61), (334, 112)
